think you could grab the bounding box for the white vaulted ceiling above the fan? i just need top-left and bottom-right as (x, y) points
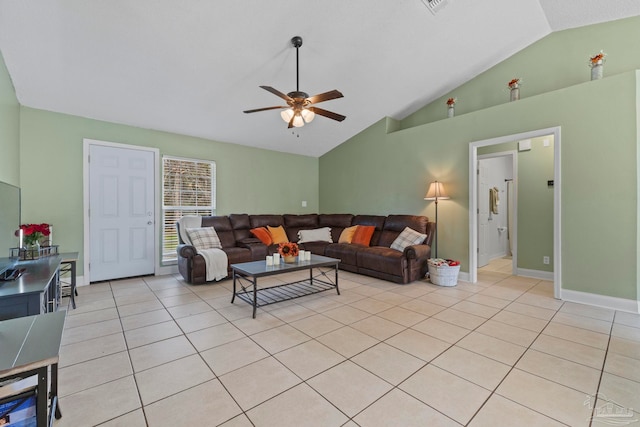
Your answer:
(0, 0), (640, 156)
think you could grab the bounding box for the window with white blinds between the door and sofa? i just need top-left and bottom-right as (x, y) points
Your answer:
(162, 156), (216, 264)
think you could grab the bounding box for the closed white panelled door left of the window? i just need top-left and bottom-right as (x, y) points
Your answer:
(89, 144), (155, 282)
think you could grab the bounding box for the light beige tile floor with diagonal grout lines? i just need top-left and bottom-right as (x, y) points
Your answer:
(54, 260), (640, 427)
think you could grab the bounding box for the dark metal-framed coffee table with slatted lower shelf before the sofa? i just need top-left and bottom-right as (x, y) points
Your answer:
(231, 255), (340, 319)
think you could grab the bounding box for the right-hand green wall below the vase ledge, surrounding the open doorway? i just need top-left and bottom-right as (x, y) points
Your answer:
(320, 71), (638, 299)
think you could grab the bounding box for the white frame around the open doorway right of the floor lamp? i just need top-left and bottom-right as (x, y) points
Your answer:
(469, 126), (562, 298)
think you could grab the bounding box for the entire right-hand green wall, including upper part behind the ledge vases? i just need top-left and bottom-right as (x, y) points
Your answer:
(320, 17), (640, 300)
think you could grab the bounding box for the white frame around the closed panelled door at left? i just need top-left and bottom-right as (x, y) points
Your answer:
(82, 138), (160, 284)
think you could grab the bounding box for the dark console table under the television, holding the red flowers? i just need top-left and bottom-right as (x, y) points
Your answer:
(0, 255), (63, 320)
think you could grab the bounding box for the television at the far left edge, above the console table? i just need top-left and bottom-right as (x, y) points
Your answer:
(0, 181), (20, 275)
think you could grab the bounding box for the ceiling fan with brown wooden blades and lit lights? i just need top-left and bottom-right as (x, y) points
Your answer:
(244, 36), (346, 128)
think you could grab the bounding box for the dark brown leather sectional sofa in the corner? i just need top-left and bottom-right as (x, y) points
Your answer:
(177, 214), (435, 284)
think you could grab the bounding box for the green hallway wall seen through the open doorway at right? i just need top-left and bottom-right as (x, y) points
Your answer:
(478, 135), (554, 272)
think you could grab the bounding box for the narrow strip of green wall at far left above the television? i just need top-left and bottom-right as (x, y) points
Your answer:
(0, 52), (20, 186)
